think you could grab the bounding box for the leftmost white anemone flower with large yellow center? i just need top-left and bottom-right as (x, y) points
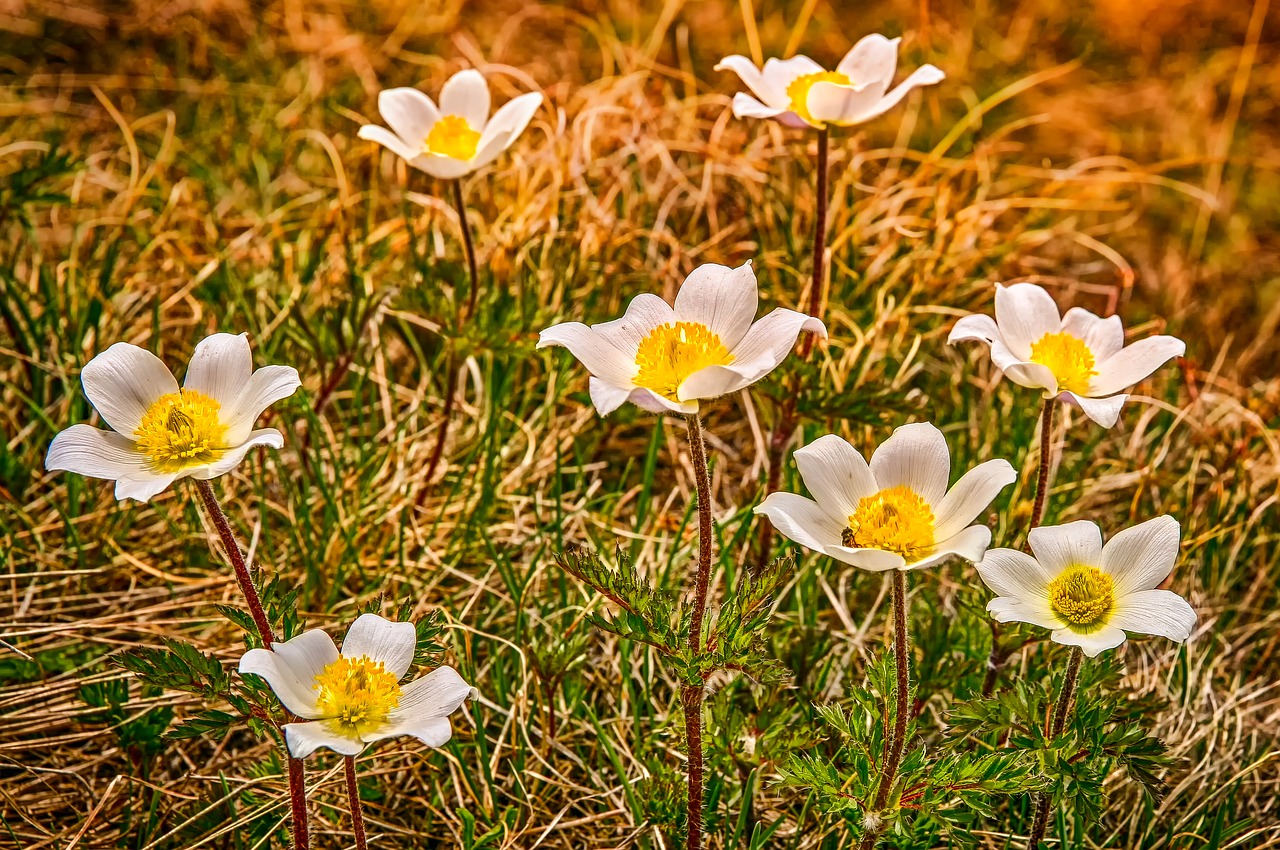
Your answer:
(45, 334), (301, 502)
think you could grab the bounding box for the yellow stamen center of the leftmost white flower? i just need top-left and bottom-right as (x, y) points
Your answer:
(133, 389), (227, 472)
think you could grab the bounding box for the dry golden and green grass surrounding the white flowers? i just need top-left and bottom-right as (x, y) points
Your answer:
(0, 0), (1280, 850)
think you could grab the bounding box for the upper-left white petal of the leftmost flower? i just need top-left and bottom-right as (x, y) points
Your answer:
(81, 342), (178, 437)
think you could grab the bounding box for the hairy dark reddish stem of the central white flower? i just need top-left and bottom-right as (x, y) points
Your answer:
(680, 413), (712, 850)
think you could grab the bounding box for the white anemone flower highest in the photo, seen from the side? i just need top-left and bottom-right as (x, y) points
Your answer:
(716, 36), (946, 129)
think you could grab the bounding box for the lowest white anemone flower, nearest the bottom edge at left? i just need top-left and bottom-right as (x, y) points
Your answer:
(239, 614), (477, 759)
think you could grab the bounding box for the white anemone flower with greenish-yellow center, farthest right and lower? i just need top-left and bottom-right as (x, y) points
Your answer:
(978, 516), (1196, 658)
